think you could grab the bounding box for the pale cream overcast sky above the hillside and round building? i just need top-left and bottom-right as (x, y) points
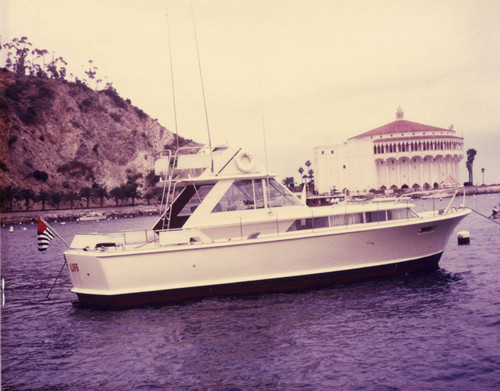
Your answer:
(0, 0), (500, 184)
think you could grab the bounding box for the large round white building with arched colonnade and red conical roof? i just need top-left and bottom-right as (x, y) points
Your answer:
(313, 107), (464, 194)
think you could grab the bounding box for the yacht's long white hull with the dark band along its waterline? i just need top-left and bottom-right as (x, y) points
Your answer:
(65, 210), (469, 306)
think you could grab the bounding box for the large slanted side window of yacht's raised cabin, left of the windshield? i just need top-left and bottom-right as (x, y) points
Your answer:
(212, 179), (264, 213)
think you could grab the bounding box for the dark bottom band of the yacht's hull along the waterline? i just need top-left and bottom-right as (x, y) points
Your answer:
(77, 253), (442, 308)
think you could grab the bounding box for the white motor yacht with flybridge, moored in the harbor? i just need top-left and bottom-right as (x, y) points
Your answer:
(64, 146), (470, 307)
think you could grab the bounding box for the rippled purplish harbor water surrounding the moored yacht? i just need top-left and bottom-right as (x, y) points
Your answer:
(1, 194), (500, 391)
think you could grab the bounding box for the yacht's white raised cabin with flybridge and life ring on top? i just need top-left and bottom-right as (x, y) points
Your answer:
(150, 146), (305, 231)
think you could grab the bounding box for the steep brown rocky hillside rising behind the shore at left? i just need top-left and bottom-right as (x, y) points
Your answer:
(0, 69), (195, 199)
